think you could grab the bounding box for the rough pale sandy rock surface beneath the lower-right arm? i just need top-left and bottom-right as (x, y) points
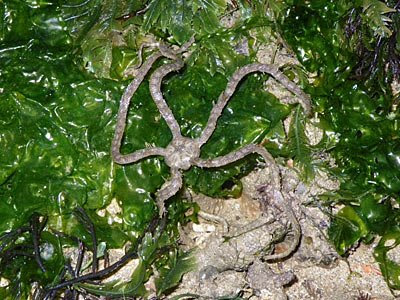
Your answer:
(171, 164), (395, 300)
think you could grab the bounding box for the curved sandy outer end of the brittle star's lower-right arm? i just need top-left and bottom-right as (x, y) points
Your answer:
(263, 189), (301, 260)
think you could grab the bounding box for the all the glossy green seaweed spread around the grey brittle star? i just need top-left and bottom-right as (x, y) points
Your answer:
(0, 0), (400, 299)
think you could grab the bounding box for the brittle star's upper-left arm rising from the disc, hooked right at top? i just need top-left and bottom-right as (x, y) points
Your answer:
(150, 59), (183, 139)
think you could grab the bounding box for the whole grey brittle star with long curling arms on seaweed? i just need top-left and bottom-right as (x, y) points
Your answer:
(111, 38), (311, 259)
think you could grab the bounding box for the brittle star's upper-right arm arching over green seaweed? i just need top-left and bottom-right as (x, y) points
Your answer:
(198, 63), (311, 145)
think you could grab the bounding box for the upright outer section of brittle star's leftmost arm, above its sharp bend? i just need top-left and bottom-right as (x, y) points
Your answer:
(111, 51), (162, 163)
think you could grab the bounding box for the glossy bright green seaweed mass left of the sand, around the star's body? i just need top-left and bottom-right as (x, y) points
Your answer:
(0, 0), (289, 298)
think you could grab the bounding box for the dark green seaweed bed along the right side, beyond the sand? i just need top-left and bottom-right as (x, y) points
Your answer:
(280, 1), (400, 288)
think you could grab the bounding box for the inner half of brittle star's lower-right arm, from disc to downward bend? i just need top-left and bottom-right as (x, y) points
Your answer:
(194, 144), (280, 188)
